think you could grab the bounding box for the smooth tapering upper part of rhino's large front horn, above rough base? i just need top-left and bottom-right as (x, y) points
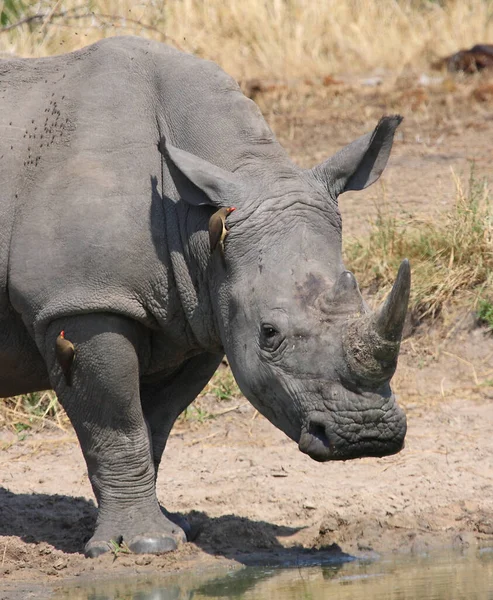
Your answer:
(375, 259), (411, 342)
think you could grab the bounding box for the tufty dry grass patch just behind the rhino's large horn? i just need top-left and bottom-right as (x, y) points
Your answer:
(345, 166), (493, 318)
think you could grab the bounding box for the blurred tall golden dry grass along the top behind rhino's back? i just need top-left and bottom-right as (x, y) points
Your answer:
(0, 0), (493, 79)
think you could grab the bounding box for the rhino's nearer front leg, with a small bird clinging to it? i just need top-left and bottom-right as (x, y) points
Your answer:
(45, 314), (185, 557)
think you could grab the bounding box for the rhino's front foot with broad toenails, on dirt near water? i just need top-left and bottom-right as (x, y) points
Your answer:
(84, 511), (186, 558)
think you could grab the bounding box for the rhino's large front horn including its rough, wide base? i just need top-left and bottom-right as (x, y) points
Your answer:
(342, 260), (411, 385)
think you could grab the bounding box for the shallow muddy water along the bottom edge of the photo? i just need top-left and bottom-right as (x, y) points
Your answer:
(56, 548), (493, 600)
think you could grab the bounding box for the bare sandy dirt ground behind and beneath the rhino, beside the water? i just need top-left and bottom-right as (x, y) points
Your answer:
(0, 70), (493, 599)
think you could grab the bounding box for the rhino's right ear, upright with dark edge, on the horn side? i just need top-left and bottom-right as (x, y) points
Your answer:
(312, 115), (402, 197)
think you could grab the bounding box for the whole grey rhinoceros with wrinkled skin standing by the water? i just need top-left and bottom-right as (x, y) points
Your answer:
(0, 38), (409, 556)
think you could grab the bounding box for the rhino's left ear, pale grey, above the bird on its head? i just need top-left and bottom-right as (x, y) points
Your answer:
(159, 138), (240, 208)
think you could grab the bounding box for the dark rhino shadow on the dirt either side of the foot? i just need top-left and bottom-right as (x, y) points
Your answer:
(0, 487), (351, 566)
